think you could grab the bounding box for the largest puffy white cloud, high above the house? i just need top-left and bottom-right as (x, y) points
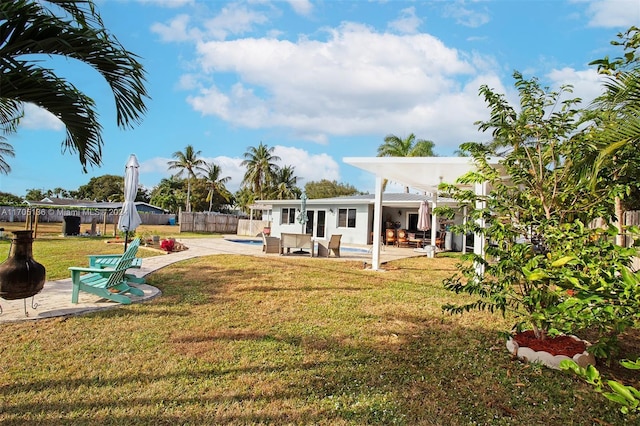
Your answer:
(188, 23), (480, 151)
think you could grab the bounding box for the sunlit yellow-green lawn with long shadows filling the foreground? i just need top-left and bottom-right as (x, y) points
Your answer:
(0, 240), (639, 425)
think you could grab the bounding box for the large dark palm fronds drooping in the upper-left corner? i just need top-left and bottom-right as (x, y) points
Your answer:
(0, 0), (149, 172)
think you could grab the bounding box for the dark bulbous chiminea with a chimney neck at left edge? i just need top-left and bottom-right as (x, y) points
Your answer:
(0, 231), (46, 300)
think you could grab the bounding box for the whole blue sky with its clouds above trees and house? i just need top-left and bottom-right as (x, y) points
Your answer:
(5, 0), (640, 196)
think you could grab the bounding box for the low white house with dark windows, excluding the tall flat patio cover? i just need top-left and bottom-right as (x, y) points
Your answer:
(256, 193), (463, 250)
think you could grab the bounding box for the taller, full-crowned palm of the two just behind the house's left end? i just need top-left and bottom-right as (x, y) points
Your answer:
(240, 142), (280, 199)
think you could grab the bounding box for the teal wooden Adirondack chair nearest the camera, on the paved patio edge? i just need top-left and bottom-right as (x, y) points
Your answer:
(69, 238), (144, 305)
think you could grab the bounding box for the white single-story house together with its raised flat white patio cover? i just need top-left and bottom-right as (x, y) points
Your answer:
(255, 157), (498, 270)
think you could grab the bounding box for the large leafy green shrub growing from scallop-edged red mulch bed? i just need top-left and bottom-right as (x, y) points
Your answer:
(438, 73), (639, 368)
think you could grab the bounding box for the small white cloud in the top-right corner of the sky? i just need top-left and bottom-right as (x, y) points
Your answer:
(587, 0), (640, 28)
